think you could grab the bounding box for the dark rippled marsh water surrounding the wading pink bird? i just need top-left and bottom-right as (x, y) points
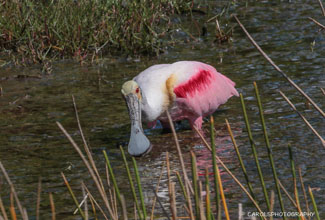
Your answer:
(0, 1), (325, 219)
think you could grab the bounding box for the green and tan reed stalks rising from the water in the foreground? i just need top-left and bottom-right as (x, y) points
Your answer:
(0, 83), (320, 220)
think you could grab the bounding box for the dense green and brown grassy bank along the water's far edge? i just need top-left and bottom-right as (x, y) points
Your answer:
(0, 0), (192, 64)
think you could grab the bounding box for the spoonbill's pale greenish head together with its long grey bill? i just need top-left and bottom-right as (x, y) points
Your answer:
(121, 80), (151, 156)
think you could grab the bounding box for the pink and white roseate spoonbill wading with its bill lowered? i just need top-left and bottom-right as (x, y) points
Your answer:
(121, 61), (238, 156)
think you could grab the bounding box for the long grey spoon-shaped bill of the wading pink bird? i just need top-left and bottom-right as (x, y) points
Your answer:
(124, 93), (151, 156)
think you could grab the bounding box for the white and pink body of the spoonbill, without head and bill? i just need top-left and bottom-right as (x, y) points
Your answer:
(134, 61), (238, 129)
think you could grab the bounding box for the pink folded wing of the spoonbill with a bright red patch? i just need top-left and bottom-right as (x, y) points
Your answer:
(174, 64), (238, 116)
